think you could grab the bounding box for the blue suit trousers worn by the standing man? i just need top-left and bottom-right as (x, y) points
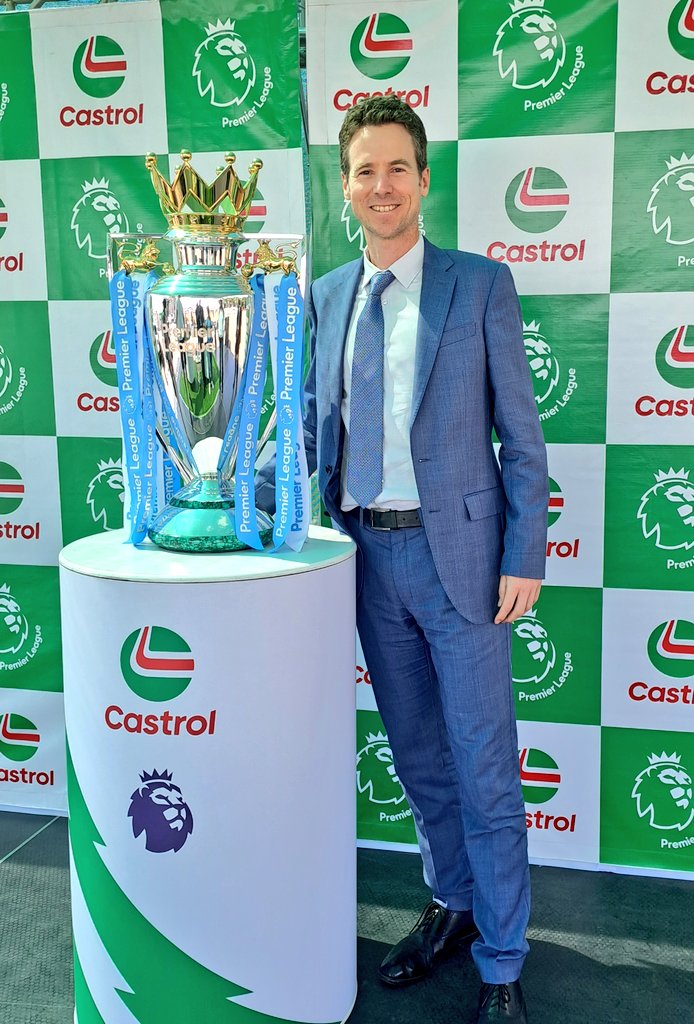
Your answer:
(345, 514), (530, 983)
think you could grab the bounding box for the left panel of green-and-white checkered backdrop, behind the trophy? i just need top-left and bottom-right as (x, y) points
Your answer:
(0, 0), (305, 813)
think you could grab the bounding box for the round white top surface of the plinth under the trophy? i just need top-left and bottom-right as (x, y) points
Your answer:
(58, 526), (356, 583)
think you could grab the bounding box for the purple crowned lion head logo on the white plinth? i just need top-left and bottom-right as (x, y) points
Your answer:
(128, 771), (192, 853)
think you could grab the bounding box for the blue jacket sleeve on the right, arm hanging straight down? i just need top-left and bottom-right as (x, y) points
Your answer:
(484, 263), (549, 580)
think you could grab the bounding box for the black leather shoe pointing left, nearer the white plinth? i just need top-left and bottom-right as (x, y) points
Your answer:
(379, 903), (479, 985)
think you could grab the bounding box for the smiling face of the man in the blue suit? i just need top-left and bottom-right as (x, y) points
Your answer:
(342, 124), (429, 244)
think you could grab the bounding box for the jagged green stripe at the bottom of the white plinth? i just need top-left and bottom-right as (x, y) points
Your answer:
(68, 752), (334, 1024)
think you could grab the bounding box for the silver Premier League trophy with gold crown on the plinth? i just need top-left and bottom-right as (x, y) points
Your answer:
(112, 151), (301, 552)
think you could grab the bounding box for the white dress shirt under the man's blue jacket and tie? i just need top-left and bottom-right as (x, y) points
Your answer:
(340, 234), (424, 512)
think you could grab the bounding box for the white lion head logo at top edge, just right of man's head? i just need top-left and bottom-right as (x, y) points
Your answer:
(492, 0), (566, 89)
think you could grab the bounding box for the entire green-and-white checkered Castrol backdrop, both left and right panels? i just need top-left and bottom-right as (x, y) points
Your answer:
(0, 0), (694, 874)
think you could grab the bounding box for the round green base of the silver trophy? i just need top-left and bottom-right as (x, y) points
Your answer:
(147, 474), (272, 553)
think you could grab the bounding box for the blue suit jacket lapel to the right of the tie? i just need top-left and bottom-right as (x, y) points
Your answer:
(410, 239), (456, 426)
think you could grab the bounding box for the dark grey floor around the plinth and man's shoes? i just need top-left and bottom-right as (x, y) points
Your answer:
(0, 812), (694, 1024)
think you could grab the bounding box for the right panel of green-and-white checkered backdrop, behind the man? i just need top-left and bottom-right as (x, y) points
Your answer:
(307, 0), (694, 874)
